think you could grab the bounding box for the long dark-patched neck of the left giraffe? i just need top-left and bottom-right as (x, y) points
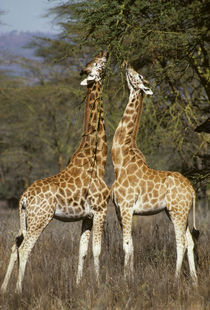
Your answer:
(73, 82), (107, 177)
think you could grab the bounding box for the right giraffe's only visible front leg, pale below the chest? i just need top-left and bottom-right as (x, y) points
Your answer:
(122, 211), (134, 279)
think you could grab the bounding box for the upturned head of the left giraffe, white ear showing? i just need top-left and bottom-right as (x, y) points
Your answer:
(80, 51), (108, 85)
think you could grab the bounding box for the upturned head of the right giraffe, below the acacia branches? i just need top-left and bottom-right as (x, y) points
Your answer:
(126, 67), (153, 95)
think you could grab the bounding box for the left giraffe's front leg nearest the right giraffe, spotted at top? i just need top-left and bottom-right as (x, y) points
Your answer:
(92, 212), (106, 283)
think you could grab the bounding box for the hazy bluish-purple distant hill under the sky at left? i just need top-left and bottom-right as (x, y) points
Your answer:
(0, 30), (53, 58)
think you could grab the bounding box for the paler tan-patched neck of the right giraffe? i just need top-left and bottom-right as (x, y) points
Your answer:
(112, 91), (144, 167)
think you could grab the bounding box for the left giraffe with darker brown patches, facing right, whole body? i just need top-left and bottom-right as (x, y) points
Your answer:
(1, 52), (110, 293)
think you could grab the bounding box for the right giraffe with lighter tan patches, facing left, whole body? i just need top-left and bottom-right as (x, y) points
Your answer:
(110, 66), (198, 285)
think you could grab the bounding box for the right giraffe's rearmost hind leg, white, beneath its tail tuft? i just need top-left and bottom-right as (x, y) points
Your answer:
(186, 227), (198, 286)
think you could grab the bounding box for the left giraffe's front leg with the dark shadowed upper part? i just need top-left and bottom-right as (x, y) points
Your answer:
(76, 218), (93, 285)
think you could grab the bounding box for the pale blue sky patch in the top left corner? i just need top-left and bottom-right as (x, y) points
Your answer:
(0, 0), (60, 33)
